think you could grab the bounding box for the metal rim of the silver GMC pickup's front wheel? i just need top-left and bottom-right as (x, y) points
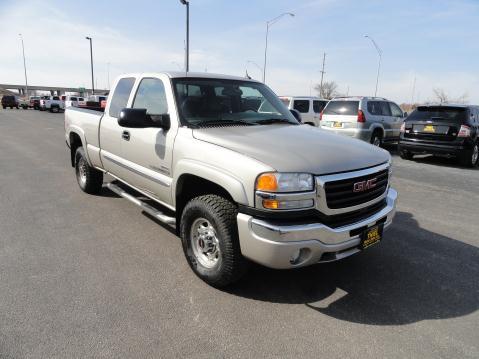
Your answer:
(190, 218), (221, 268)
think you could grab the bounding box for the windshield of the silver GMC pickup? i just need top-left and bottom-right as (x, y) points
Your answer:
(173, 78), (299, 127)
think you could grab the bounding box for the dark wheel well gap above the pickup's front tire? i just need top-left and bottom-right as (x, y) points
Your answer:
(175, 174), (234, 232)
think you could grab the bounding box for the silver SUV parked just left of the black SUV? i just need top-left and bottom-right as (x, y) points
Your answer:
(321, 97), (407, 146)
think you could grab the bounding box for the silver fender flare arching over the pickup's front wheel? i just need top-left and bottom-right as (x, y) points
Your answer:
(175, 159), (248, 206)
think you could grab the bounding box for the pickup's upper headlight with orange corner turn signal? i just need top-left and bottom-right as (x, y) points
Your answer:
(256, 172), (314, 193)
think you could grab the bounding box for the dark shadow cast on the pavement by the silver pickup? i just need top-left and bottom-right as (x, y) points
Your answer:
(228, 212), (479, 325)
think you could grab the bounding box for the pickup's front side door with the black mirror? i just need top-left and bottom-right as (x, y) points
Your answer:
(121, 76), (178, 203)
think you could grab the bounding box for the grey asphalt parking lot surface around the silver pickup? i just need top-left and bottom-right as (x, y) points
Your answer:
(0, 110), (479, 358)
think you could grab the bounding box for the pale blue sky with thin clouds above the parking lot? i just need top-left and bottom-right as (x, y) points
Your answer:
(0, 0), (479, 103)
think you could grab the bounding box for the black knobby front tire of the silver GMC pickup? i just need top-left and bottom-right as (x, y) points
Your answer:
(180, 194), (247, 288)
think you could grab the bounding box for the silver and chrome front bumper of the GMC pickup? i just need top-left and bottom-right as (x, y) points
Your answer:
(237, 188), (397, 269)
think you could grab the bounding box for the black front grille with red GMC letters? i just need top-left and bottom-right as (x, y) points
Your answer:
(324, 169), (388, 209)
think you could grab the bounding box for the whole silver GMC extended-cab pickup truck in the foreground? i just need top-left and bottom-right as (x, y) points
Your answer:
(65, 72), (397, 287)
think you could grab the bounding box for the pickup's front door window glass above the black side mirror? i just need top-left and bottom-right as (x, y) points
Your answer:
(133, 79), (168, 115)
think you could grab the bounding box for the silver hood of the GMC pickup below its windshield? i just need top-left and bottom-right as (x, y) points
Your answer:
(193, 124), (390, 175)
